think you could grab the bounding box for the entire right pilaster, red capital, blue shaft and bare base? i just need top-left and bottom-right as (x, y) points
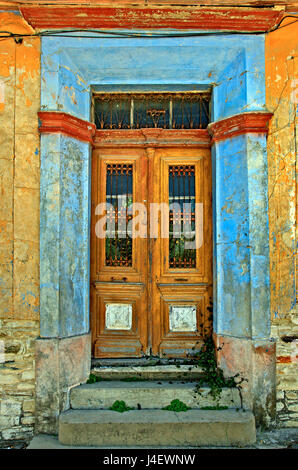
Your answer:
(209, 112), (275, 425)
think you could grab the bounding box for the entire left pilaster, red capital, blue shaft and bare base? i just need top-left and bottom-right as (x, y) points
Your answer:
(36, 112), (95, 433)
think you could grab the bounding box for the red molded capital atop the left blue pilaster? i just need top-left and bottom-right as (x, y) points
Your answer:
(38, 111), (96, 143)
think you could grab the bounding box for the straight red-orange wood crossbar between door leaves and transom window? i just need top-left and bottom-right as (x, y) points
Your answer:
(93, 128), (211, 148)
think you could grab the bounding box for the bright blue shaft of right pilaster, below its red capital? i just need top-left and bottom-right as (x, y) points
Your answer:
(212, 134), (270, 338)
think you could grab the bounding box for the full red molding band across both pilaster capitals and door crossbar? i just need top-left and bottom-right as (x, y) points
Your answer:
(38, 111), (272, 148)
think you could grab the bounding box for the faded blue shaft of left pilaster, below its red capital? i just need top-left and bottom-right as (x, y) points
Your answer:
(40, 134), (90, 337)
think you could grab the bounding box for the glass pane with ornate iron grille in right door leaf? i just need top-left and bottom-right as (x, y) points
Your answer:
(169, 165), (196, 269)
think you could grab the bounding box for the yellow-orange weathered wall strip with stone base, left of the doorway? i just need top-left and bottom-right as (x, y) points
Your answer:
(0, 12), (40, 441)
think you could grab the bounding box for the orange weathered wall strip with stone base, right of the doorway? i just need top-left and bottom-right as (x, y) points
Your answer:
(266, 19), (298, 426)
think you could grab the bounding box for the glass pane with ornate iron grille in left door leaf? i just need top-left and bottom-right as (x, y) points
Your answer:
(106, 163), (133, 266)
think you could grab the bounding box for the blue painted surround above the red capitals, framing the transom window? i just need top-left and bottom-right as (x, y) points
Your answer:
(41, 34), (265, 120)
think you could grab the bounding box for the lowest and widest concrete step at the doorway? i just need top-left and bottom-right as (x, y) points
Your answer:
(59, 410), (256, 447)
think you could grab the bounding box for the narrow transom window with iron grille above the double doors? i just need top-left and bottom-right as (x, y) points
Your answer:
(93, 92), (210, 129)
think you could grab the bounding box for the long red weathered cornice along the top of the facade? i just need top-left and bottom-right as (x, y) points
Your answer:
(20, 5), (283, 31)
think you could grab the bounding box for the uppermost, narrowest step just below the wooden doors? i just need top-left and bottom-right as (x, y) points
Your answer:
(91, 364), (203, 380)
